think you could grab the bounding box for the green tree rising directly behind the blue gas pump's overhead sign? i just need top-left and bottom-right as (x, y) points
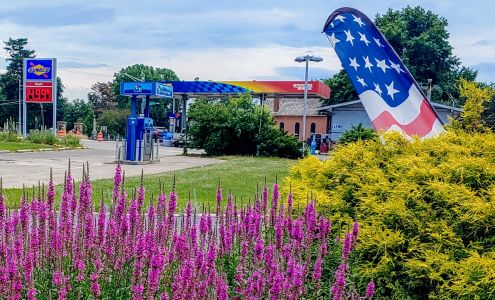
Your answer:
(113, 64), (179, 108)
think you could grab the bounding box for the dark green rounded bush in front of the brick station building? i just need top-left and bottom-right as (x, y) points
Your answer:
(189, 95), (301, 158)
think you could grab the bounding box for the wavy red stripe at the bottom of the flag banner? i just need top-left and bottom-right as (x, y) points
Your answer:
(372, 100), (437, 137)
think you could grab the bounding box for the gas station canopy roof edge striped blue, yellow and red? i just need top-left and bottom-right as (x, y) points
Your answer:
(162, 80), (330, 99)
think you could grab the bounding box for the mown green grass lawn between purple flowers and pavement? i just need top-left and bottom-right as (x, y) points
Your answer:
(0, 156), (296, 207)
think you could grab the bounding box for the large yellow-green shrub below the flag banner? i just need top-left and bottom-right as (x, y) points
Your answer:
(284, 131), (495, 299)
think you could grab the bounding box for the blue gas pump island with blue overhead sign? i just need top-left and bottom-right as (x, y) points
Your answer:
(120, 82), (173, 163)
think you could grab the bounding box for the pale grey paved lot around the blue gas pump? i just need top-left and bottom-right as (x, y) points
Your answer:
(0, 140), (222, 188)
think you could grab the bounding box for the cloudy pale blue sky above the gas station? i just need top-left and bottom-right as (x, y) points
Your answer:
(0, 0), (495, 99)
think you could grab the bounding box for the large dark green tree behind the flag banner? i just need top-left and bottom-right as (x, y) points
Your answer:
(325, 6), (477, 105)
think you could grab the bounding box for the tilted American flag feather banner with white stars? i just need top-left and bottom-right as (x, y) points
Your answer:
(323, 7), (443, 138)
